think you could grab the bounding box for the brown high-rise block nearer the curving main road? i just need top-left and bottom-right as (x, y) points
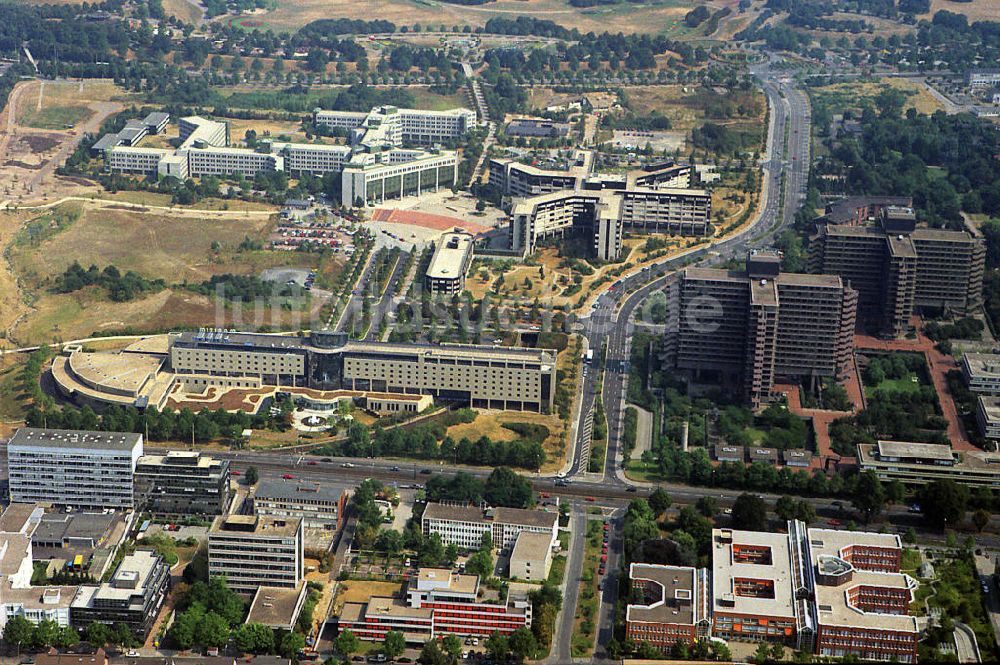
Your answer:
(667, 252), (857, 407)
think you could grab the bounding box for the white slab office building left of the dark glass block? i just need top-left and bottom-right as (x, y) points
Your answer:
(7, 427), (142, 510)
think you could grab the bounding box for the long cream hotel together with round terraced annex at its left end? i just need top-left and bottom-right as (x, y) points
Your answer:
(51, 330), (556, 413)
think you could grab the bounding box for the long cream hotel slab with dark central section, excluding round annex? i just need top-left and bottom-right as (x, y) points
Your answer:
(170, 332), (556, 412)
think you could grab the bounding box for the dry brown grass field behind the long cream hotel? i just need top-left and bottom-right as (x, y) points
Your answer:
(0, 204), (340, 343)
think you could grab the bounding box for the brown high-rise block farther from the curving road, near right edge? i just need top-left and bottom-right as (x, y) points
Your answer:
(809, 206), (986, 337)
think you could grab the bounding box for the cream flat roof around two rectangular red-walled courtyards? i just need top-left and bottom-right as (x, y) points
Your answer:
(712, 529), (796, 619)
